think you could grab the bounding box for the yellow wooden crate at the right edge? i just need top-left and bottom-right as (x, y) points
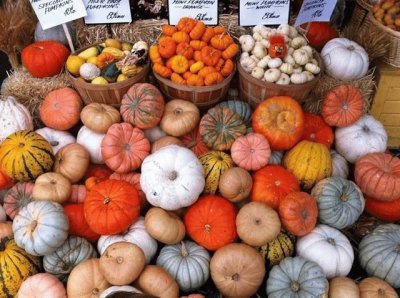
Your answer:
(370, 62), (400, 149)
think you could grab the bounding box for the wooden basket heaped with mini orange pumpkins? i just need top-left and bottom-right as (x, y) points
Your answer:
(149, 17), (239, 109)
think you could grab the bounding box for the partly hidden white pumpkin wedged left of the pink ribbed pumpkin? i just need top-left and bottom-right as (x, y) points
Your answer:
(76, 125), (105, 164)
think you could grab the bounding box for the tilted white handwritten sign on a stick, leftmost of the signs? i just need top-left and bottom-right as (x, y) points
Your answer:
(30, 0), (86, 30)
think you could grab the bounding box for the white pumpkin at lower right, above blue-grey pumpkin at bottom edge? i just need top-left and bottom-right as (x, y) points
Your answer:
(296, 224), (354, 279)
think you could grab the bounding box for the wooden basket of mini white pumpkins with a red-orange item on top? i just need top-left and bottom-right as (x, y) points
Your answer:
(237, 24), (323, 107)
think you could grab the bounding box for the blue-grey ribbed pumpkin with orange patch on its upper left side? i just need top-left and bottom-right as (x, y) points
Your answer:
(311, 177), (365, 230)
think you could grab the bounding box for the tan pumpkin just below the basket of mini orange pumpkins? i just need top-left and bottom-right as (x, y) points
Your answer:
(160, 99), (200, 137)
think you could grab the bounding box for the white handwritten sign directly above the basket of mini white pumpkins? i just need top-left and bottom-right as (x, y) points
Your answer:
(239, 0), (290, 26)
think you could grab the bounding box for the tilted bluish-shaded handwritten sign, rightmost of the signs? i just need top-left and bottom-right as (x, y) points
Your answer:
(294, 0), (336, 27)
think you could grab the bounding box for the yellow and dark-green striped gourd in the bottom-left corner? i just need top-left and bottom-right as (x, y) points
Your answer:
(0, 238), (41, 298)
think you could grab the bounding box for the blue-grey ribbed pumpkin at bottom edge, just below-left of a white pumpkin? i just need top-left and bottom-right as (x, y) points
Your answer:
(267, 257), (329, 298)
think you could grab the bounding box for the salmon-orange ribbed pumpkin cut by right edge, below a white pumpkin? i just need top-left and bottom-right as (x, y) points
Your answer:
(354, 153), (400, 201)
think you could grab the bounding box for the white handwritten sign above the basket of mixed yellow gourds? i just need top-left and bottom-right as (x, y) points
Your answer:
(83, 0), (132, 24)
